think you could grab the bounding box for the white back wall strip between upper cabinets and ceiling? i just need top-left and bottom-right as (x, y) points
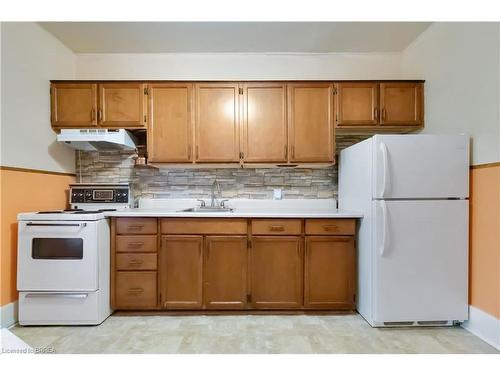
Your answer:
(77, 53), (401, 80)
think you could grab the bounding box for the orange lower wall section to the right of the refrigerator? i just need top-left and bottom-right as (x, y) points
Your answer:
(469, 163), (500, 319)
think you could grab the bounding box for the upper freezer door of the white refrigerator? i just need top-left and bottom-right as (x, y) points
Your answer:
(372, 134), (469, 199)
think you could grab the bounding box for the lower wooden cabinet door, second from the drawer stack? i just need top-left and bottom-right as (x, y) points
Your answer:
(204, 236), (247, 309)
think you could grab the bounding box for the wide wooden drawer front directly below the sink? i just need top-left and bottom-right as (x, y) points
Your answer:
(161, 218), (247, 234)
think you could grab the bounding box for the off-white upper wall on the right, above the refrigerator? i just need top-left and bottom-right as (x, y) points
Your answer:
(401, 23), (500, 164)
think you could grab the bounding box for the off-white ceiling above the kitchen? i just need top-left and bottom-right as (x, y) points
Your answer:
(40, 22), (430, 53)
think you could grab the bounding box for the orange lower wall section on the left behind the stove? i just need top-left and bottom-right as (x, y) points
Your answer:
(0, 170), (74, 306)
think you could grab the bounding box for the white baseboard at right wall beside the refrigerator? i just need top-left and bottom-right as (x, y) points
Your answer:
(462, 306), (500, 350)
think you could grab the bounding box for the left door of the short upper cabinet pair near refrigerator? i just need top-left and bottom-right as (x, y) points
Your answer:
(337, 82), (379, 126)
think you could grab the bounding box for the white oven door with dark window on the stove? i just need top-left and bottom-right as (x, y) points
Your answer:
(17, 221), (98, 291)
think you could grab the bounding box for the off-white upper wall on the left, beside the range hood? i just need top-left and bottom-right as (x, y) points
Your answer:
(1, 22), (76, 172)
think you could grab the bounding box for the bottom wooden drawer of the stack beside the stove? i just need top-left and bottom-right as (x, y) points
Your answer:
(115, 271), (157, 308)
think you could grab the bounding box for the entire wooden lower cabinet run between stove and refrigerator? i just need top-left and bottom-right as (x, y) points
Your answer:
(111, 218), (356, 311)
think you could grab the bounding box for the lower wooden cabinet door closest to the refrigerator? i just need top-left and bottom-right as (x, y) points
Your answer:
(304, 236), (356, 309)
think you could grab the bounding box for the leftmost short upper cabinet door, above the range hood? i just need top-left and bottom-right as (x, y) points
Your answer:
(50, 83), (97, 128)
